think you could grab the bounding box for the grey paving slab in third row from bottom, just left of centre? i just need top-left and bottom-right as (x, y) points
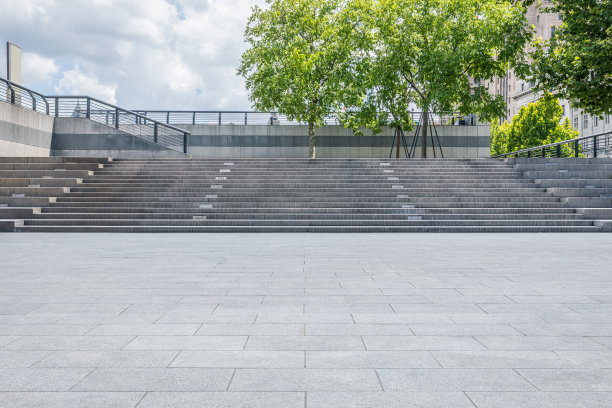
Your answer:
(170, 350), (304, 368)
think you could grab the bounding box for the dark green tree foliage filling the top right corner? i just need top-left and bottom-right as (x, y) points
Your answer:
(531, 0), (612, 115)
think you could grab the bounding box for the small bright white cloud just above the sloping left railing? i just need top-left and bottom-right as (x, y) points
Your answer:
(55, 66), (117, 104)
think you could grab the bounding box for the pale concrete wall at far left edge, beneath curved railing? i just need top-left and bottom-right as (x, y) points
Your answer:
(0, 102), (53, 157)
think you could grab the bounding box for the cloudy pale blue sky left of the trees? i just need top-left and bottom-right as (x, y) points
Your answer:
(0, 0), (265, 110)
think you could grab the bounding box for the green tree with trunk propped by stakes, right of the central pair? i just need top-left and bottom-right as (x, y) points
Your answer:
(342, 0), (532, 157)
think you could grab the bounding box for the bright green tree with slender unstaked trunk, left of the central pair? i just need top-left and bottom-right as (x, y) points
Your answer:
(238, 0), (370, 158)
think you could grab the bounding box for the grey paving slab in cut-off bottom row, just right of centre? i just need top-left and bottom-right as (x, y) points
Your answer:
(307, 391), (474, 408)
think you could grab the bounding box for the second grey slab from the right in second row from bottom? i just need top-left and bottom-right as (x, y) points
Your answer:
(377, 368), (535, 392)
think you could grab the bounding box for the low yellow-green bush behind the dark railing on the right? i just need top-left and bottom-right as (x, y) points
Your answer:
(491, 94), (579, 156)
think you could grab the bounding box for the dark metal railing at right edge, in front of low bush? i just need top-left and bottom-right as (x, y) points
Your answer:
(493, 132), (612, 159)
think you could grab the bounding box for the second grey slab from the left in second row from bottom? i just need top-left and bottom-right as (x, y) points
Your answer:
(73, 368), (233, 391)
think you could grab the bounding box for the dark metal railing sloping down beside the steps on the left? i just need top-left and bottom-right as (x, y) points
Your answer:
(46, 96), (191, 153)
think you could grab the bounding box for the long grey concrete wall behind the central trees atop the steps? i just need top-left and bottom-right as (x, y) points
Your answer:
(180, 125), (490, 158)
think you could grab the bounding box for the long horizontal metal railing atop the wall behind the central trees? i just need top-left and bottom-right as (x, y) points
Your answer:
(133, 109), (476, 126)
